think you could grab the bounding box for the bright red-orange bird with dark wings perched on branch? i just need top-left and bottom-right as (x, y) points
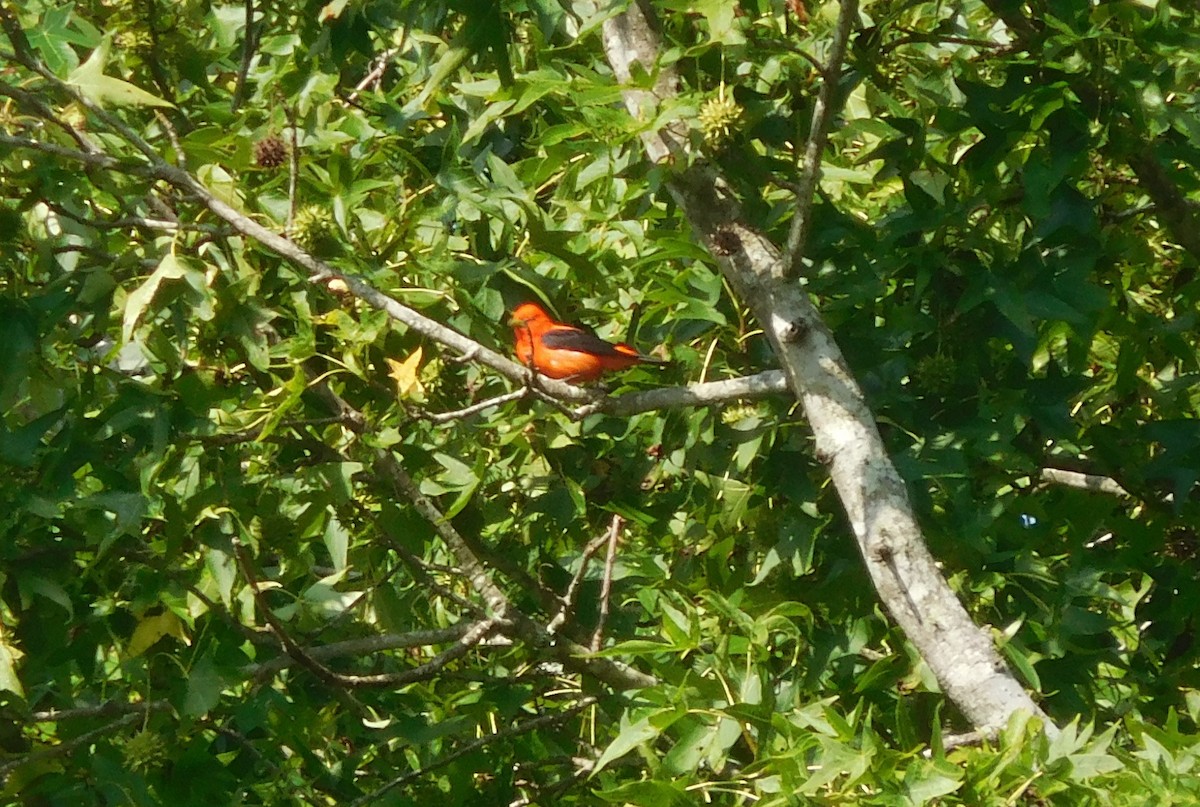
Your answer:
(510, 303), (667, 383)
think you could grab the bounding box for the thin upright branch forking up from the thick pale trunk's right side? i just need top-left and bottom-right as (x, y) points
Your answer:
(784, 0), (858, 275)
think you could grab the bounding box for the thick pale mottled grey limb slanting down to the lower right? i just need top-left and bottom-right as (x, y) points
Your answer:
(604, 5), (1056, 733)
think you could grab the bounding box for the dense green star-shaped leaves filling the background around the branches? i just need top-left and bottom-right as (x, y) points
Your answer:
(0, 0), (1200, 805)
